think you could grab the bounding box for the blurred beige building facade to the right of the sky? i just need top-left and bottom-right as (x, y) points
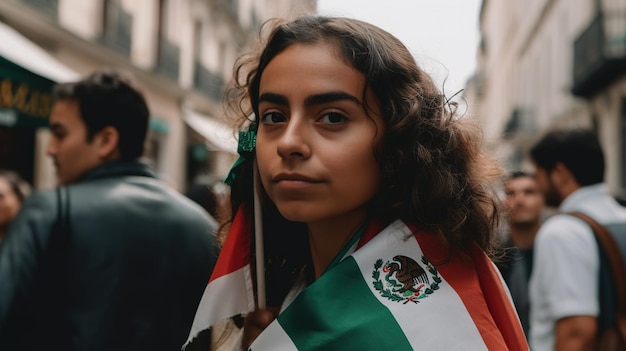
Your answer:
(465, 0), (626, 198)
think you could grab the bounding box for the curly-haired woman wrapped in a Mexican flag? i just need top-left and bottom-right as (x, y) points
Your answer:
(182, 16), (528, 350)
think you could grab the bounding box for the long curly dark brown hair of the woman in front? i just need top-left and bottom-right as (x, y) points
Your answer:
(219, 15), (501, 308)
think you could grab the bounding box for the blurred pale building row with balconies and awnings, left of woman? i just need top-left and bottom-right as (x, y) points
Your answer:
(0, 0), (316, 191)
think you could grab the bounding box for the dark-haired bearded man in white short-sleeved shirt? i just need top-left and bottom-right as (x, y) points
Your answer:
(530, 129), (626, 351)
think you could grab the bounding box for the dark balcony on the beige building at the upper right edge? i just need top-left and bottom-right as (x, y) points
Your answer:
(572, 10), (626, 98)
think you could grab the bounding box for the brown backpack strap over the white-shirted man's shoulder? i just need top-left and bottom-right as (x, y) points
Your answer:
(568, 212), (626, 340)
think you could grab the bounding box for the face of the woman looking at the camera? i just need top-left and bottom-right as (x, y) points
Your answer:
(256, 44), (383, 228)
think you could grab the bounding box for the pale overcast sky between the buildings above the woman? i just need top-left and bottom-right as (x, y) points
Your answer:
(317, 0), (481, 96)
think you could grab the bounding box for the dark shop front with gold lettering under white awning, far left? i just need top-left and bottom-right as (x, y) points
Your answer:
(0, 22), (78, 187)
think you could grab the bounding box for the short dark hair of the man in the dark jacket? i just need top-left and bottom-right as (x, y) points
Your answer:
(53, 69), (150, 161)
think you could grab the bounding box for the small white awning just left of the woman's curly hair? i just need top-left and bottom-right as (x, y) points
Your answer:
(183, 108), (237, 154)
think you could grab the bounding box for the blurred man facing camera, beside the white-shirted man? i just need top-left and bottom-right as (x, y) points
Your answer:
(496, 171), (544, 336)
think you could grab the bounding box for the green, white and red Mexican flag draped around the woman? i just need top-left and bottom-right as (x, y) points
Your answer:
(188, 211), (528, 351)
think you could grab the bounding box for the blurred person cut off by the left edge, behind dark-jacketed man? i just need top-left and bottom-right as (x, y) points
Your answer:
(0, 169), (30, 242)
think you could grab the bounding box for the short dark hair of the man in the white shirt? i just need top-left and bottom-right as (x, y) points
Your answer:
(530, 129), (604, 186)
